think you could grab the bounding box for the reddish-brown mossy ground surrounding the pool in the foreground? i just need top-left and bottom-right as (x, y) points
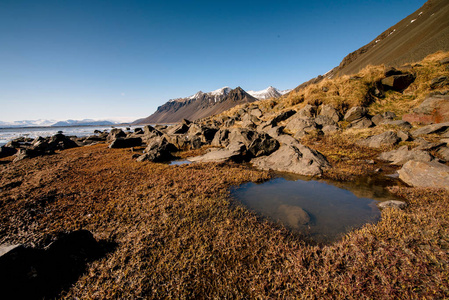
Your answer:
(0, 144), (449, 299)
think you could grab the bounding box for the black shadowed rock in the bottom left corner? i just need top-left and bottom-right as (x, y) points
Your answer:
(0, 230), (116, 299)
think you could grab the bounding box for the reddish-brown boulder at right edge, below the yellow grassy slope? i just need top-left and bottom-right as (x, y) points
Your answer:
(402, 95), (449, 124)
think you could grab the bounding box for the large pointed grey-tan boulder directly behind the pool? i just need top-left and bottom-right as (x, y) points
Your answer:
(251, 142), (330, 176)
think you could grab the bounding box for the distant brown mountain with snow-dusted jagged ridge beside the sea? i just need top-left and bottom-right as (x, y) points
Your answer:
(134, 87), (257, 124)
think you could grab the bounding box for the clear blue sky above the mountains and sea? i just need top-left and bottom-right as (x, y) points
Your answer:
(0, 0), (425, 121)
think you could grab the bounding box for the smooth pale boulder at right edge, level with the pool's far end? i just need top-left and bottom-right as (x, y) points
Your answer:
(398, 160), (449, 190)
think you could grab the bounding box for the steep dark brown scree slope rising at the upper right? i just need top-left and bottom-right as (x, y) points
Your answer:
(326, 0), (449, 76)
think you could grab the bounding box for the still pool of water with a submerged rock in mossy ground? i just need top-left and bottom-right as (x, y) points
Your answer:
(232, 174), (400, 242)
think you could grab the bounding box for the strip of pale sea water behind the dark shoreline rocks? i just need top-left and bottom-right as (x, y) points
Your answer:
(0, 125), (138, 146)
